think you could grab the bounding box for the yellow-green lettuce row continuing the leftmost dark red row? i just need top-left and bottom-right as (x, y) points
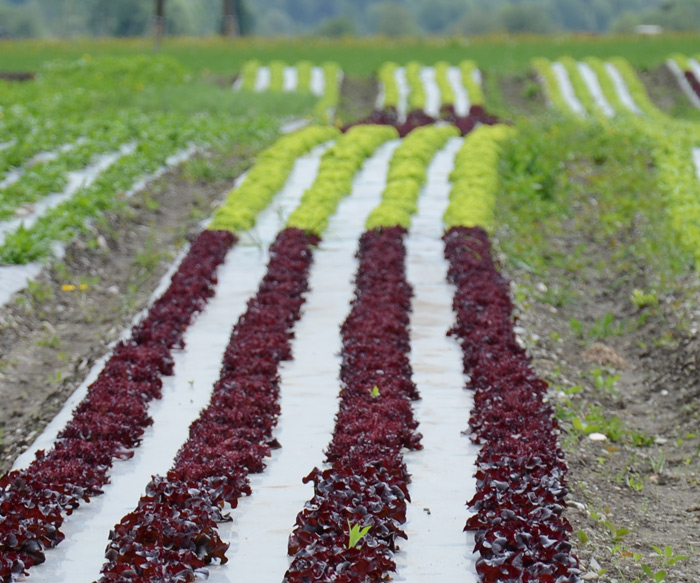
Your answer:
(209, 126), (340, 232)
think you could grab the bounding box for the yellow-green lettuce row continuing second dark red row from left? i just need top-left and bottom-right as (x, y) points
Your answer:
(287, 126), (398, 235)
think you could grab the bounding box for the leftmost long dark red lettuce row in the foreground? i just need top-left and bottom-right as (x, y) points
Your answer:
(0, 231), (235, 583)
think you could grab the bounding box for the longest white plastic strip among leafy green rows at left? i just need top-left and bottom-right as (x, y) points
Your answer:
(0, 143), (136, 245)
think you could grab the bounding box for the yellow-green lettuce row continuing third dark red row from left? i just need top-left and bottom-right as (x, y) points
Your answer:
(366, 126), (459, 229)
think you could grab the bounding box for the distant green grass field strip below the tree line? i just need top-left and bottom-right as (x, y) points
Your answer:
(0, 34), (700, 76)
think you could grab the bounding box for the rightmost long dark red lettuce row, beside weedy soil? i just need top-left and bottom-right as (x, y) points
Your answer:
(444, 227), (580, 583)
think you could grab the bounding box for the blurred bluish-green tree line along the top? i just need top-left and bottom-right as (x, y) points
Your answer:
(0, 0), (700, 38)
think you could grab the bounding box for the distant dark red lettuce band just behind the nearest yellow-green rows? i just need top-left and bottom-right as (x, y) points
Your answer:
(343, 105), (499, 138)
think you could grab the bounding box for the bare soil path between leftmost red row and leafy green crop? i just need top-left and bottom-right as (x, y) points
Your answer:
(0, 149), (251, 475)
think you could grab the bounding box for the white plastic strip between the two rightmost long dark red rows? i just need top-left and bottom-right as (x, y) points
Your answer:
(394, 138), (479, 583)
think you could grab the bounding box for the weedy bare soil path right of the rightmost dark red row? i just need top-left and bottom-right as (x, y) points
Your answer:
(499, 193), (700, 583)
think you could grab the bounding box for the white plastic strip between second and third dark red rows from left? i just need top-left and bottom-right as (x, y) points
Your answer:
(204, 140), (399, 583)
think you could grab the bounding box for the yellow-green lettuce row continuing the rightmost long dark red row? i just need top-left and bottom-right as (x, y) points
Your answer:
(443, 125), (515, 230)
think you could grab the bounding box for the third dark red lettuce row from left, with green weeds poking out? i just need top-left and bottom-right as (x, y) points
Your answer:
(284, 227), (421, 583)
